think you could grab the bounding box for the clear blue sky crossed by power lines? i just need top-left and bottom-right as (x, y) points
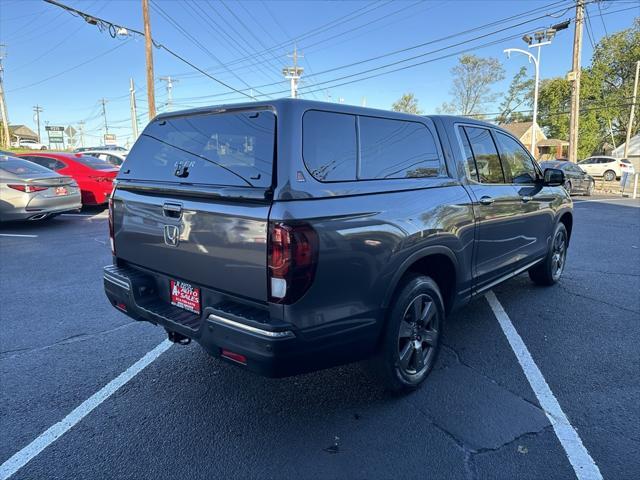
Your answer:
(0, 0), (640, 144)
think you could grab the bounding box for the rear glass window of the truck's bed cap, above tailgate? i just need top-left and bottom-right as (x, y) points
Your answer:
(119, 111), (276, 188)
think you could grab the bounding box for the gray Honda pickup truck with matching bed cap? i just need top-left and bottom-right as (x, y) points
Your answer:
(104, 99), (573, 390)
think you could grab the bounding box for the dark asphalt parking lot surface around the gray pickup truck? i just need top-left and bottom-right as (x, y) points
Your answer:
(0, 198), (640, 479)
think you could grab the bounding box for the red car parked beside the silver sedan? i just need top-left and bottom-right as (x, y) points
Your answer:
(18, 152), (119, 205)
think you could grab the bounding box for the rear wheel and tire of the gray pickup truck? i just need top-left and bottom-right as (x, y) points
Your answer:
(372, 275), (445, 392)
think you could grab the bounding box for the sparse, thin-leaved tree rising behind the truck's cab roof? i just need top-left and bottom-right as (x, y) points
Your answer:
(439, 54), (504, 115)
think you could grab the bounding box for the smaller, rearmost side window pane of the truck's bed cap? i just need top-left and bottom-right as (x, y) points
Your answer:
(302, 110), (357, 182)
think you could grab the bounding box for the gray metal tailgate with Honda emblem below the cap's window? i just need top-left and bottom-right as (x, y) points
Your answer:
(113, 189), (269, 301)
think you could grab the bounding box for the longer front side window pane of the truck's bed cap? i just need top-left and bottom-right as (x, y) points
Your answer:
(358, 116), (443, 180)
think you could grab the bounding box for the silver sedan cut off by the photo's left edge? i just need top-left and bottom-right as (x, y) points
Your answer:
(0, 155), (82, 222)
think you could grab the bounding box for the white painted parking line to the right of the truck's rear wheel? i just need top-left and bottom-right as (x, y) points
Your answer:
(485, 291), (602, 480)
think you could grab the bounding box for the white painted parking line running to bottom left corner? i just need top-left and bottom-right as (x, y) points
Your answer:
(0, 340), (173, 480)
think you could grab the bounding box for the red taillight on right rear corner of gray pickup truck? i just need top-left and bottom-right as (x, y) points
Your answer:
(267, 223), (318, 304)
